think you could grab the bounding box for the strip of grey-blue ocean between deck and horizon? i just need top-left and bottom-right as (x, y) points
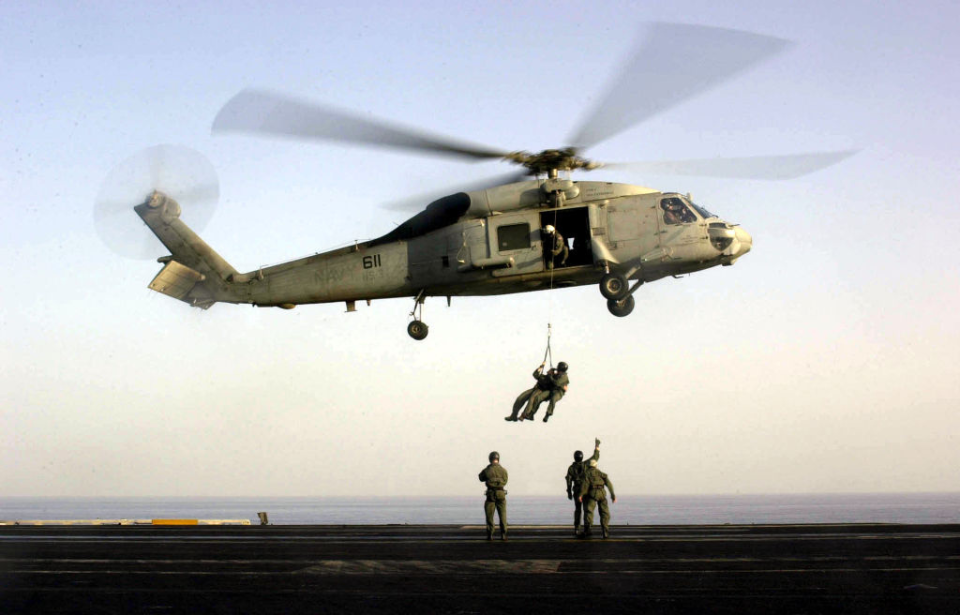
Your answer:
(0, 493), (960, 525)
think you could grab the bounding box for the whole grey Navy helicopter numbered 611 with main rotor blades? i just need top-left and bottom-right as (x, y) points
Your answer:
(103, 24), (853, 340)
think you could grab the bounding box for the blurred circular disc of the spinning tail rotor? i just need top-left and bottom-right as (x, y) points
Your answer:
(93, 145), (220, 259)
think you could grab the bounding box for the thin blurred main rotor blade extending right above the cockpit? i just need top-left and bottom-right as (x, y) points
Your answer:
(603, 150), (859, 180)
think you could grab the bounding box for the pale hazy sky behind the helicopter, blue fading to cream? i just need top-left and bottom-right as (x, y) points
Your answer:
(0, 0), (960, 496)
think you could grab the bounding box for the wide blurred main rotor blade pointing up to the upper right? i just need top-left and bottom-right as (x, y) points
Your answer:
(569, 23), (791, 149)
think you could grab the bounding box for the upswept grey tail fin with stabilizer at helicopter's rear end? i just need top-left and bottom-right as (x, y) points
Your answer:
(133, 192), (237, 309)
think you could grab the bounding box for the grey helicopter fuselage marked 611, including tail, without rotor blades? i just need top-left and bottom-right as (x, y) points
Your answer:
(135, 179), (752, 332)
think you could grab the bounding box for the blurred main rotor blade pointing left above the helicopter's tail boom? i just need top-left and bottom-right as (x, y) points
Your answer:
(213, 89), (507, 159)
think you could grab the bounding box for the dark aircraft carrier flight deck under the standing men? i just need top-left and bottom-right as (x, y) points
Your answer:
(0, 524), (960, 615)
